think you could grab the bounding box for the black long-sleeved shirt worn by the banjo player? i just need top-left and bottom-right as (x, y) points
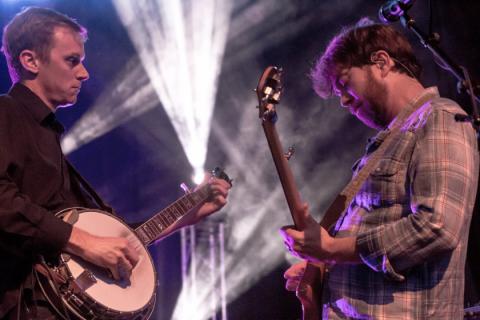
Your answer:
(0, 84), (95, 318)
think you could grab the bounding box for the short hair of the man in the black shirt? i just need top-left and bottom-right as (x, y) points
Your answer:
(1, 7), (87, 83)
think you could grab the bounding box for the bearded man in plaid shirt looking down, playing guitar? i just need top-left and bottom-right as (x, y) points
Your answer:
(281, 21), (479, 319)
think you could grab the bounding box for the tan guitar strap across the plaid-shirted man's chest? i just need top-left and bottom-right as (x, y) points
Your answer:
(320, 89), (437, 230)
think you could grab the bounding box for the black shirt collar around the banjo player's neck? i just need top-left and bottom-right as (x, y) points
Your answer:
(8, 83), (65, 134)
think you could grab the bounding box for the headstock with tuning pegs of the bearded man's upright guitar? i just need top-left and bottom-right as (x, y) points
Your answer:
(255, 66), (282, 122)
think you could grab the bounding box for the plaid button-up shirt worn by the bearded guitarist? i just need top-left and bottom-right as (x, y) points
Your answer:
(323, 88), (478, 320)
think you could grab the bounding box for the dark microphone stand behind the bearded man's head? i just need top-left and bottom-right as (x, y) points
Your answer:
(394, 10), (480, 134)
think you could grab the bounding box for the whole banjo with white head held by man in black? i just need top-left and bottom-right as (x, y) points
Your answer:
(34, 168), (231, 320)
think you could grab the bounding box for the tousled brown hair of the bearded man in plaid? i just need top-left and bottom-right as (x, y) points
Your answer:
(310, 18), (422, 98)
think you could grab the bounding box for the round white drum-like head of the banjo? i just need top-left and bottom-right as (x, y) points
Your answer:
(62, 209), (157, 313)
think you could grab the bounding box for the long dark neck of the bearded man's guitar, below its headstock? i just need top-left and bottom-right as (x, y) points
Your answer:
(262, 121), (305, 230)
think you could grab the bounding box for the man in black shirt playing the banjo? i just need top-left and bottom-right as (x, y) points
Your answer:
(0, 8), (230, 319)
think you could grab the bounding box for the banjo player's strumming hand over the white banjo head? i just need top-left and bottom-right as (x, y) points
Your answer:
(65, 226), (139, 281)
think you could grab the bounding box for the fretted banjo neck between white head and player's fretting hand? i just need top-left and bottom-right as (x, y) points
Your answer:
(135, 185), (210, 245)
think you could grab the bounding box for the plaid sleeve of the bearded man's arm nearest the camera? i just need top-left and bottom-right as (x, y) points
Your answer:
(357, 99), (478, 281)
